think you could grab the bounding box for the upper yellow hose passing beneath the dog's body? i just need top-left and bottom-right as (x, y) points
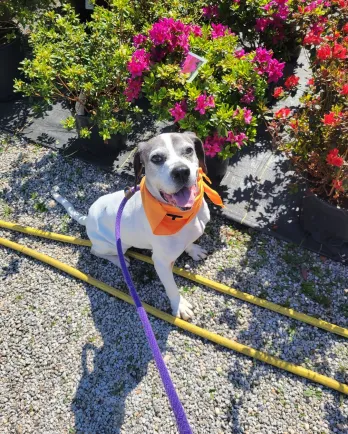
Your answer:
(0, 220), (348, 338)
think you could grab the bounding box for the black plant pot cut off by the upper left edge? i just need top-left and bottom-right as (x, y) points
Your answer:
(0, 31), (24, 102)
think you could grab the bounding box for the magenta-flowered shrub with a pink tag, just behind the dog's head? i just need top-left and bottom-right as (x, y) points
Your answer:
(125, 18), (284, 158)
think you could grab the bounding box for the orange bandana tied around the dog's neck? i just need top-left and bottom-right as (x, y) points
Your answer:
(140, 169), (224, 235)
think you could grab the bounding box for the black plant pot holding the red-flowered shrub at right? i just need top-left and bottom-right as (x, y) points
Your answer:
(300, 194), (348, 259)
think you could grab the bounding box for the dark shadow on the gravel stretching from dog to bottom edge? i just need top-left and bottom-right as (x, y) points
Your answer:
(71, 242), (172, 434)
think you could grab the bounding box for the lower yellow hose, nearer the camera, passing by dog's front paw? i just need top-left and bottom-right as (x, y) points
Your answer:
(0, 232), (348, 395)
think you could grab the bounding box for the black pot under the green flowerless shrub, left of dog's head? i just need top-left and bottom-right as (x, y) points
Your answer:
(75, 115), (127, 157)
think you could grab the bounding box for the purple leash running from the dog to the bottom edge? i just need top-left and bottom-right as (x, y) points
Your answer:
(115, 187), (192, 434)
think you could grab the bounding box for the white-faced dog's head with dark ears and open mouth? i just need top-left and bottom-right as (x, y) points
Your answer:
(133, 132), (207, 209)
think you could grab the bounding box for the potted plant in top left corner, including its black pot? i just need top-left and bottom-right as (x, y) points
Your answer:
(0, 0), (49, 102)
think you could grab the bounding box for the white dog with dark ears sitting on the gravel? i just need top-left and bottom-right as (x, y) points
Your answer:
(53, 132), (222, 320)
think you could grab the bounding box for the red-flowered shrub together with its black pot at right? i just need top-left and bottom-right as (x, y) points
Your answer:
(270, 2), (348, 256)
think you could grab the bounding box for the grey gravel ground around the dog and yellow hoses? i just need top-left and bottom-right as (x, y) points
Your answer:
(0, 136), (348, 434)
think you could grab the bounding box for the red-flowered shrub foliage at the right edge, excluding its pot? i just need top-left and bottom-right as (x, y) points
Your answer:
(270, 0), (348, 206)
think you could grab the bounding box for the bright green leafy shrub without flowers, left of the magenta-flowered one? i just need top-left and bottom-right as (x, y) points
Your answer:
(15, 4), (137, 152)
